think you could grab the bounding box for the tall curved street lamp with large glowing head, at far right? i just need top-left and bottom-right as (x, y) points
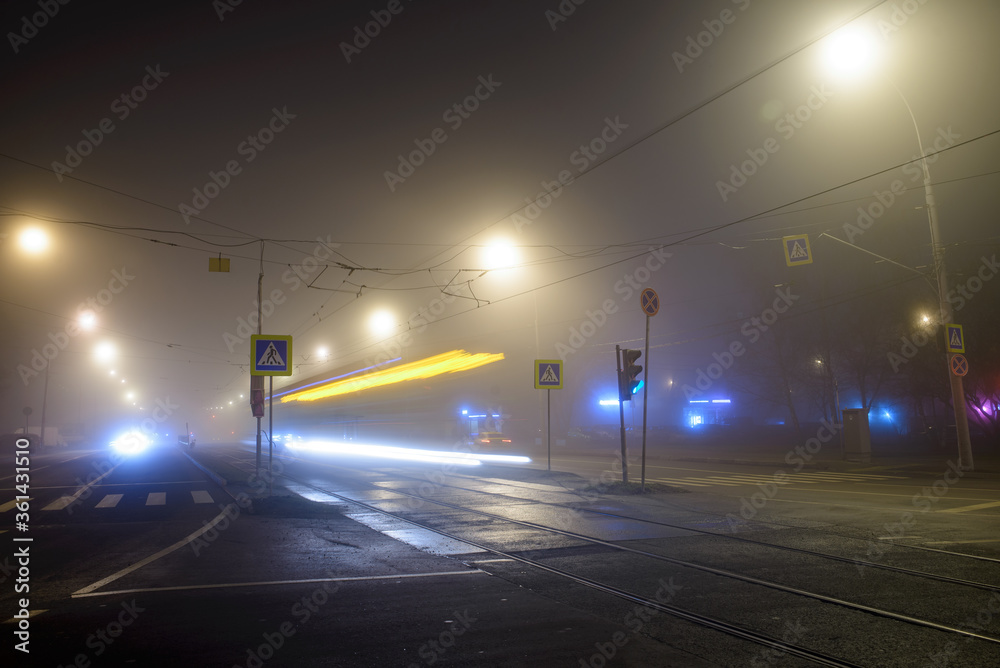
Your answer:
(824, 24), (973, 471)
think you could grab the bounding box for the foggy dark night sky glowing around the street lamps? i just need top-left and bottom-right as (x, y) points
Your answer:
(0, 0), (1000, 431)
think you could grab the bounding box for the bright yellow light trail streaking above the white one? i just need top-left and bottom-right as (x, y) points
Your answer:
(281, 350), (504, 403)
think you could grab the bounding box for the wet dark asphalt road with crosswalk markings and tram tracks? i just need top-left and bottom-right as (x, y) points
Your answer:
(0, 444), (1000, 666)
